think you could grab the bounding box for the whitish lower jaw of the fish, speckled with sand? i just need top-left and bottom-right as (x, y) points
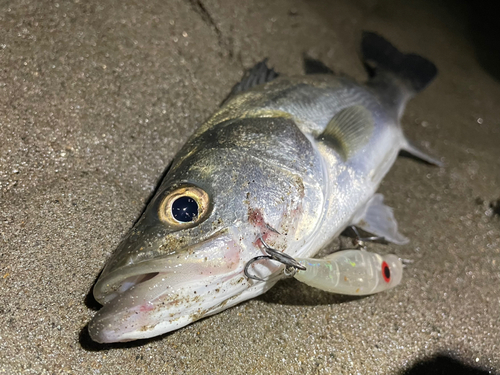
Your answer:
(88, 273), (249, 343)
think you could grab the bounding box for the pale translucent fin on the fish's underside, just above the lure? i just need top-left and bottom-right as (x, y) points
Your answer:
(353, 194), (409, 245)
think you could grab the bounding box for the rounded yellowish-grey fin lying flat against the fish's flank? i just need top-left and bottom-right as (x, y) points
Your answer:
(318, 105), (373, 160)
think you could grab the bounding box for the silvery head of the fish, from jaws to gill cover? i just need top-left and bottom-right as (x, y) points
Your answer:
(89, 117), (318, 342)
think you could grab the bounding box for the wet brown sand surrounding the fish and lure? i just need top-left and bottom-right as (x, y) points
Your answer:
(0, 0), (500, 374)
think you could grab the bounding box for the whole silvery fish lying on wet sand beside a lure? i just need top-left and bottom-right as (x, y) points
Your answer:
(88, 32), (442, 343)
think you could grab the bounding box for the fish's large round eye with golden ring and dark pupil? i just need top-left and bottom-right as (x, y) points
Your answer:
(158, 185), (209, 226)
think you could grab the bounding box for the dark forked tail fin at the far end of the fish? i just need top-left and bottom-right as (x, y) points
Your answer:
(361, 31), (437, 93)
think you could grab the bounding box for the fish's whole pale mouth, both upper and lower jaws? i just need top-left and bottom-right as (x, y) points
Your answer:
(88, 235), (249, 343)
